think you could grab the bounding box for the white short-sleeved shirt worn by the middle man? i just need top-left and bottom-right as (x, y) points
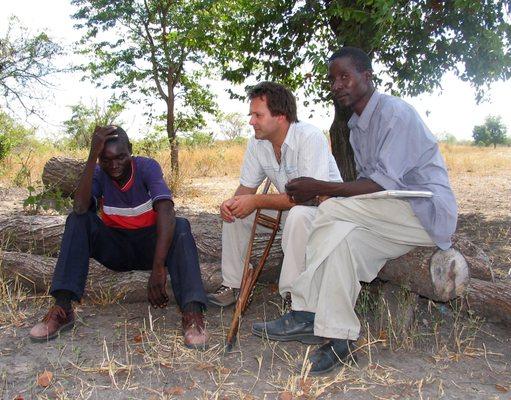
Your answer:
(240, 122), (342, 193)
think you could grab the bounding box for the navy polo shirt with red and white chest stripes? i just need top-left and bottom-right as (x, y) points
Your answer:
(92, 157), (172, 229)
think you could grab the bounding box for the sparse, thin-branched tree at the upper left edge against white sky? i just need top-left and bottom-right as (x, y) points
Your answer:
(0, 17), (63, 116)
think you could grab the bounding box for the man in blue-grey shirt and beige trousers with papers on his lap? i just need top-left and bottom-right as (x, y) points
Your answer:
(252, 47), (457, 374)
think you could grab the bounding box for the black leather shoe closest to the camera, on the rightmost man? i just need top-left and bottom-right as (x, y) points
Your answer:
(309, 339), (356, 375)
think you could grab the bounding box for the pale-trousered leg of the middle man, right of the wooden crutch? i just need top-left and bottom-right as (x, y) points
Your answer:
(279, 206), (318, 298)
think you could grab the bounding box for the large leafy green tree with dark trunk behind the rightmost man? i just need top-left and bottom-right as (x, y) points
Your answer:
(218, 0), (511, 180)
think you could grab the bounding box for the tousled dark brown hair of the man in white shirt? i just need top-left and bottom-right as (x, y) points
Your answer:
(247, 82), (298, 123)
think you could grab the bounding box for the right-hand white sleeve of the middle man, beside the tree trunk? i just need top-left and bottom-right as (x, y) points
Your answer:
(298, 130), (330, 181)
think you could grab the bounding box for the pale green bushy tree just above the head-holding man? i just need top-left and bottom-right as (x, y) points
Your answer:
(64, 98), (124, 148)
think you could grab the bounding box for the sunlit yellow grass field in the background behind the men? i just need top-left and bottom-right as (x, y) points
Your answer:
(0, 142), (511, 191)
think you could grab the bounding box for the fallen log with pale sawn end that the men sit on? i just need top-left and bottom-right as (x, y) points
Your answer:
(0, 213), (493, 301)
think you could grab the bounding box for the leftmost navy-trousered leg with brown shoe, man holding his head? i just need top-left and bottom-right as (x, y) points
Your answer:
(30, 212), (133, 341)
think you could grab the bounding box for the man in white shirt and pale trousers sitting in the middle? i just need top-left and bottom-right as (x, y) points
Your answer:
(208, 82), (342, 307)
